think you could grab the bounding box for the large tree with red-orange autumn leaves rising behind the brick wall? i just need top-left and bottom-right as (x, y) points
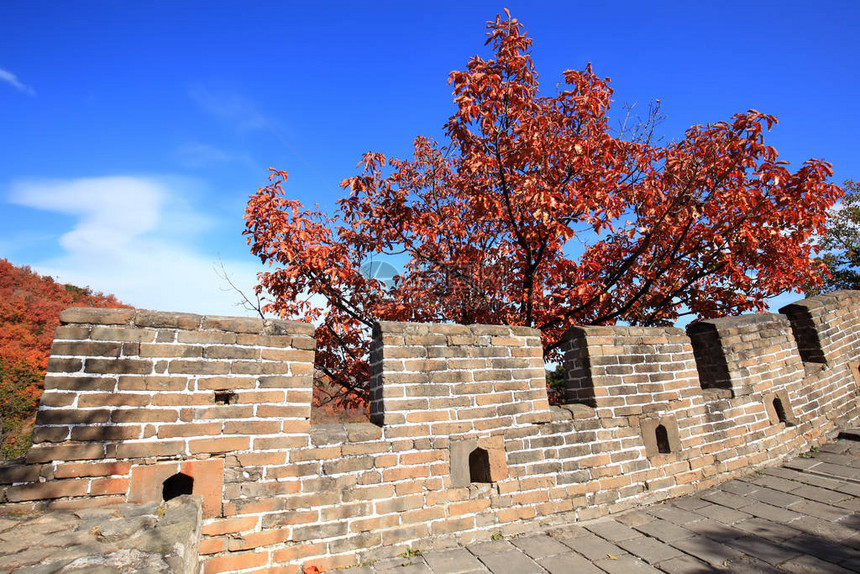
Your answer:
(245, 14), (841, 410)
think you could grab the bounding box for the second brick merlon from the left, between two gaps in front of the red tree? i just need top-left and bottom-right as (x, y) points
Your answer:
(370, 321), (550, 430)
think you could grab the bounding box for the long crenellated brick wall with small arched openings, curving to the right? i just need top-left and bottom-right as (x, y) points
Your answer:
(0, 291), (860, 574)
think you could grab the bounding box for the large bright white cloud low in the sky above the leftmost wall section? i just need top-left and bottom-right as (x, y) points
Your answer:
(9, 176), (259, 315)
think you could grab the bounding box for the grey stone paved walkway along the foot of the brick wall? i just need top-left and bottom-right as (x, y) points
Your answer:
(345, 438), (860, 574)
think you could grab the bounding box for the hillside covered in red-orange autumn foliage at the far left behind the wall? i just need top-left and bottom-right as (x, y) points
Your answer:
(0, 259), (128, 464)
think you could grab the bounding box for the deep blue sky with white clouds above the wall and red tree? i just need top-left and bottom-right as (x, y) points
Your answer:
(0, 0), (860, 314)
